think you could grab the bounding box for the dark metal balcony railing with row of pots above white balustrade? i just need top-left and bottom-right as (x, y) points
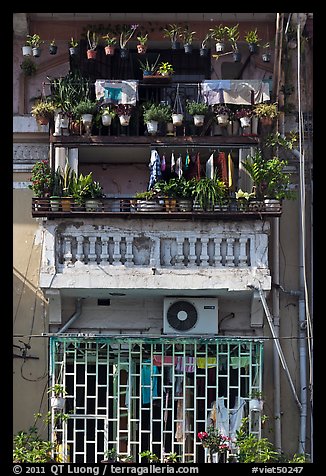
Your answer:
(32, 197), (282, 220)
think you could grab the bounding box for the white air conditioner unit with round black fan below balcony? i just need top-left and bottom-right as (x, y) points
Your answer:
(163, 298), (218, 335)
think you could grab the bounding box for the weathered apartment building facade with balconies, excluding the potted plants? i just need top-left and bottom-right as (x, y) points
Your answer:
(13, 13), (313, 462)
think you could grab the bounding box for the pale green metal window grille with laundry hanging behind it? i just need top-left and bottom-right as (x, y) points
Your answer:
(50, 337), (263, 463)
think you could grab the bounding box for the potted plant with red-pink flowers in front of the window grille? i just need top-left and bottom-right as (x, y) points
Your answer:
(197, 425), (231, 463)
